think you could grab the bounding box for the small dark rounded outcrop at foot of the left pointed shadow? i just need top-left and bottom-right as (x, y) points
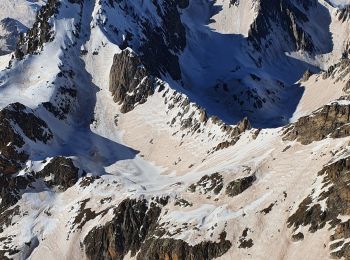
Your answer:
(36, 157), (79, 191)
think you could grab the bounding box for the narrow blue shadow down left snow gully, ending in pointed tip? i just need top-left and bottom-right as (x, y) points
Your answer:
(30, 1), (139, 174)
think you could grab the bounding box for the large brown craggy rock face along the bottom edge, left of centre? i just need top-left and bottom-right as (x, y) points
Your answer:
(84, 198), (231, 260)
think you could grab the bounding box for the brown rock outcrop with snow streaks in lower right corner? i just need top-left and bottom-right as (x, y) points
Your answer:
(288, 151), (350, 259)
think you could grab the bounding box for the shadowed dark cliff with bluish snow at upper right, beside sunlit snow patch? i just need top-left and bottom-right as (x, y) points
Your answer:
(248, 0), (334, 71)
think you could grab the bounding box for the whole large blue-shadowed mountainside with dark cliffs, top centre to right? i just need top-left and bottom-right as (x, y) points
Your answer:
(104, 1), (342, 127)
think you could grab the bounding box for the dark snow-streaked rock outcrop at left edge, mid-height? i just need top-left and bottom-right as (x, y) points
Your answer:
(0, 103), (53, 174)
